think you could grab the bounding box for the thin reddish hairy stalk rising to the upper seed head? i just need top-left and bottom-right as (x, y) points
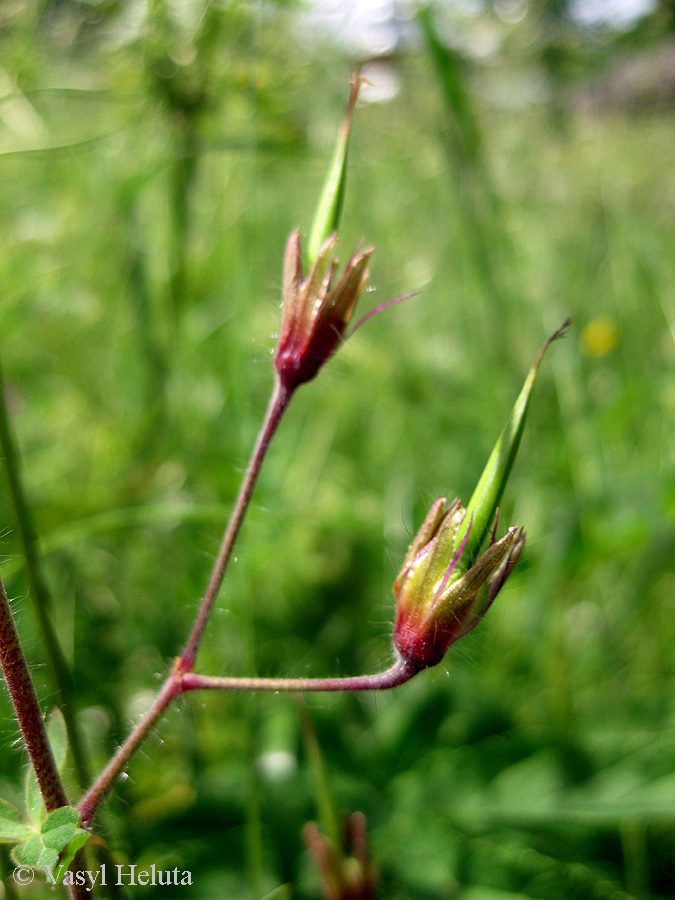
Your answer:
(177, 379), (292, 672)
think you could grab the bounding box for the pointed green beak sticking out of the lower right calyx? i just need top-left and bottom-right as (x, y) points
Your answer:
(455, 319), (570, 559)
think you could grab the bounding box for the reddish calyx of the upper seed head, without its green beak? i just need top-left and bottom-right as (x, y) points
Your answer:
(274, 231), (373, 392)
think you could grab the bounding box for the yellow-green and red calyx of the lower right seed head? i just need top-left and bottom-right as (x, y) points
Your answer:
(394, 497), (525, 670)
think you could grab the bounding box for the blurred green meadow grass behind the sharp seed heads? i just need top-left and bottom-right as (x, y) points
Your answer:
(0, 3), (675, 900)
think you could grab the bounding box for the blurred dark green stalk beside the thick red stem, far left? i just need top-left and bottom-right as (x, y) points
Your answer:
(0, 365), (90, 786)
